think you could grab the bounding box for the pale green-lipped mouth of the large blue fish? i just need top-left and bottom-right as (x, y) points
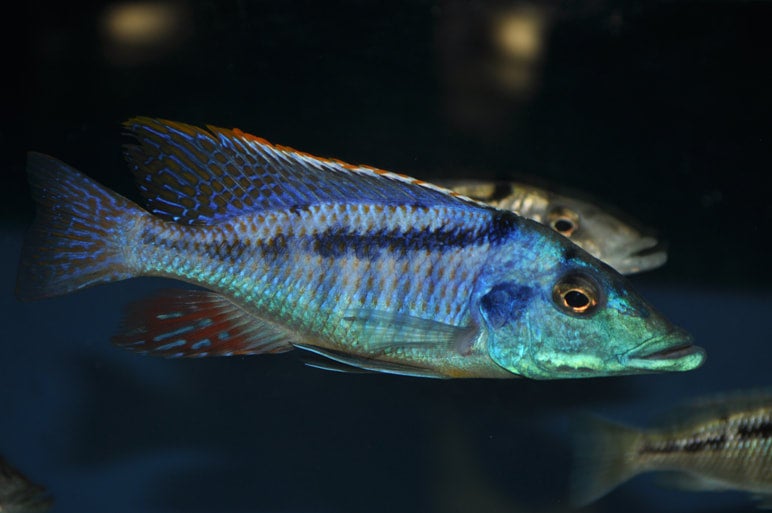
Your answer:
(622, 329), (705, 372)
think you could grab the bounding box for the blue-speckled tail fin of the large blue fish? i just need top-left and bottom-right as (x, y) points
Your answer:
(16, 152), (144, 300)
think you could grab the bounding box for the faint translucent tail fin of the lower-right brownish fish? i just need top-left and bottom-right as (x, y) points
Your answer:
(571, 415), (641, 507)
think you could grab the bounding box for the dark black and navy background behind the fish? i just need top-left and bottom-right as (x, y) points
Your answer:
(6, 0), (772, 512)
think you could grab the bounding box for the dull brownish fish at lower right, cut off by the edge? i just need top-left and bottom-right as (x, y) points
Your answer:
(571, 390), (772, 509)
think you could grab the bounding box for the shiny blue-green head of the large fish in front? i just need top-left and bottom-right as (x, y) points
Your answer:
(472, 214), (705, 379)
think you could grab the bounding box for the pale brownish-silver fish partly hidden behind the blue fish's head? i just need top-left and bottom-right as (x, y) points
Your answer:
(438, 180), (667, 274)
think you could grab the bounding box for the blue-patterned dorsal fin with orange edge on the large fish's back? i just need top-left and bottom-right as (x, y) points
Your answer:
(124, 117), (483, 224)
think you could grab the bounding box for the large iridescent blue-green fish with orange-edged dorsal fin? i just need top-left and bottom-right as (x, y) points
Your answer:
(17, 118), (705, 379)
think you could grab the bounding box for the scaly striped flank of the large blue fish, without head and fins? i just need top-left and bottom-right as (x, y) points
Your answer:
(129, 204), (507, 377)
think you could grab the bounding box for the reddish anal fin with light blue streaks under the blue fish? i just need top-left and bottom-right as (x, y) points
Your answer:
(113, 290), (292, 358)
